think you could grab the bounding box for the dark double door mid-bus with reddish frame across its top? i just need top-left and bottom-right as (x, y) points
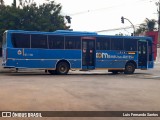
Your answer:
(82, 37), (95, 70)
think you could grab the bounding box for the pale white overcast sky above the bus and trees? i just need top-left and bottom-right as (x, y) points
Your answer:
(7, 0), (158, 34)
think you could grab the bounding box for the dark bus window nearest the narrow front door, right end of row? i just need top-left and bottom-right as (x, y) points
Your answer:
(124, 39), (137, 51)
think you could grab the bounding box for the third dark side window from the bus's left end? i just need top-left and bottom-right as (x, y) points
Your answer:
(48, 35), (64, 49)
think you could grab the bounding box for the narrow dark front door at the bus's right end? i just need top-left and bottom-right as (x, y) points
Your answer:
(138, 41), (148, 69)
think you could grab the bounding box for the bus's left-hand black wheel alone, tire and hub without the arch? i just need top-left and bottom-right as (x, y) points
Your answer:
(56, 62), (69, 75)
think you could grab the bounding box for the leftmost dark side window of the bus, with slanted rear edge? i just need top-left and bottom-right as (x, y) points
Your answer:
(12, 33), (30, 48)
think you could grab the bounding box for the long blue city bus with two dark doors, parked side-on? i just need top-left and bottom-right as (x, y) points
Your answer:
(2, 30), (154, 75)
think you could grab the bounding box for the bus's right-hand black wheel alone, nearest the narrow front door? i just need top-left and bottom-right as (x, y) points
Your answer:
(124, 63), (135, 74)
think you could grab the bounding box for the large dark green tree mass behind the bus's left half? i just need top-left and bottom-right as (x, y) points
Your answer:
(0, 0), (69, 42)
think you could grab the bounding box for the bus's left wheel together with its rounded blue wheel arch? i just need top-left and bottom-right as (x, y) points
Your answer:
(56, 60), (70, 75)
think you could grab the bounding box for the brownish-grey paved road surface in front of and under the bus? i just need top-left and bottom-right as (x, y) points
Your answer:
(0, 58), (160, 120)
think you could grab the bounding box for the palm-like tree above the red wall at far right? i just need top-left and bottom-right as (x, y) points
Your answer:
(136, 18), (157, 35)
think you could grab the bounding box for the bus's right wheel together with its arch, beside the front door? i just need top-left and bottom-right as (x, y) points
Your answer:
(124, 60), (137, 74)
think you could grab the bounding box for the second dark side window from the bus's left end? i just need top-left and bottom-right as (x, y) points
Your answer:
(31, 34), (47, 48)
